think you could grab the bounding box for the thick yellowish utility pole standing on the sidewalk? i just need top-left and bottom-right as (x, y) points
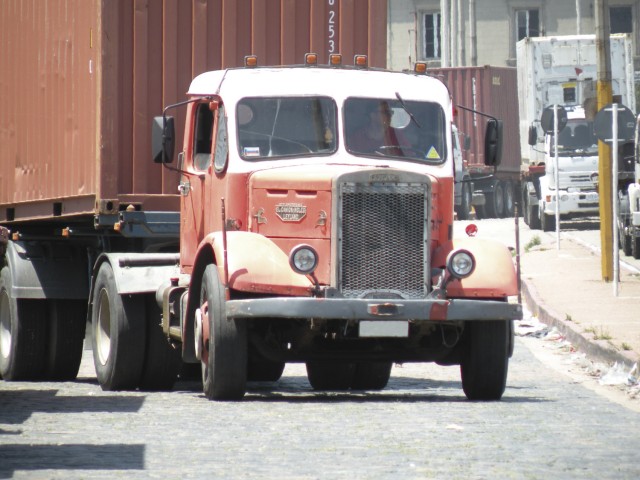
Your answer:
(595, 0), (618, 282)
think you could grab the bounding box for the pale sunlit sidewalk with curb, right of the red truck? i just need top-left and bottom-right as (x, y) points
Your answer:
(520, 236), (640, 366)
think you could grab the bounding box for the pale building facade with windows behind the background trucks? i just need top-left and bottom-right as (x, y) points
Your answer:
(387, 0), (640, 71)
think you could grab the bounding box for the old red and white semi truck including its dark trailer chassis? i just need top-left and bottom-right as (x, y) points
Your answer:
(0, 0), (522, 400)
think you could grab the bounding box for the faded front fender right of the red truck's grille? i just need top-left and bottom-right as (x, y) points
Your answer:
(431, 238), (518, 298)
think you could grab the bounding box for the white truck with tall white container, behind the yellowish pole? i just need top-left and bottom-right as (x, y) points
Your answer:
(516, 34), (636, 231)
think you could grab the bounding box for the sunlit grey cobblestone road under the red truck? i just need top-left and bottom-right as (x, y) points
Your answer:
(0, 339), (640, 479)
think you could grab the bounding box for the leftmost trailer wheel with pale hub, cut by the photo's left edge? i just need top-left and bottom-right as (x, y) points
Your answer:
(0, 267), (47, 380)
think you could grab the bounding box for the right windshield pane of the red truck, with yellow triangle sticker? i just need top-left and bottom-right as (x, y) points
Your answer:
(344, 97), (446, 163)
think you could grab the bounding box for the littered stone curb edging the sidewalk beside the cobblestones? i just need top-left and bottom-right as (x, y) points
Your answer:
(521, 278), (638, 368)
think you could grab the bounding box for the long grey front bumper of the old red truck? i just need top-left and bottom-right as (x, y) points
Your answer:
(226, 297), (522, 322)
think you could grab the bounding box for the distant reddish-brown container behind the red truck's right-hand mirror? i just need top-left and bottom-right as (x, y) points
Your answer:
(429, 66), (520, 173)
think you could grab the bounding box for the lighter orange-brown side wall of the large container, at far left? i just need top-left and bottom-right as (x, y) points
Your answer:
(0, 0), (99, 215)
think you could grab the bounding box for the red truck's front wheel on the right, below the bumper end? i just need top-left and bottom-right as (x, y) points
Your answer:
(460, 320), (511, 400)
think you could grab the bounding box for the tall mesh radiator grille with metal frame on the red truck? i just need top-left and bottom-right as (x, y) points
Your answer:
(338, 183), (430, 298)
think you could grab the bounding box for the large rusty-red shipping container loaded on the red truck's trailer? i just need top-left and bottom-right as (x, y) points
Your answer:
(0, 0), (387, 225)
